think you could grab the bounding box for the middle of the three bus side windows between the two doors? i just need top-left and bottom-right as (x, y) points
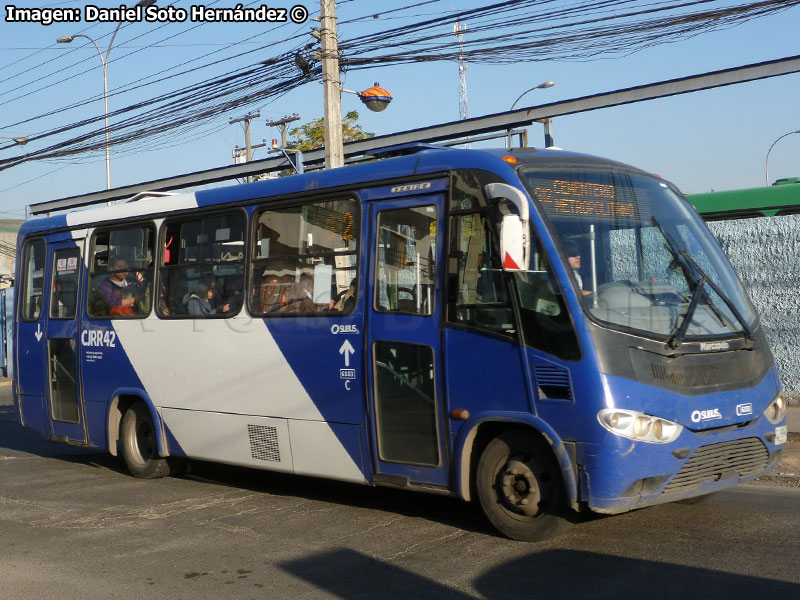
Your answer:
(156, 210), (247, 318)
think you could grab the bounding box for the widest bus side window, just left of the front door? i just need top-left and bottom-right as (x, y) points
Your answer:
(248, 200), (360, 316)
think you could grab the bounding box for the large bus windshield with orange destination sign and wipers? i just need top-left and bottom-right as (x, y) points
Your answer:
(520, 167), (756, 346)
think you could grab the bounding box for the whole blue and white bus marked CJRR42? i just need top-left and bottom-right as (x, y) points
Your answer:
(14, 146), (786, 540)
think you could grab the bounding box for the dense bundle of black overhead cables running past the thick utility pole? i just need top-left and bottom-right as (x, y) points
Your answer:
(0, 0), (800, 170)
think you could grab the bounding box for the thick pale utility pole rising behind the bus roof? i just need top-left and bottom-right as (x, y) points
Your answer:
(320, 0), (344, 169)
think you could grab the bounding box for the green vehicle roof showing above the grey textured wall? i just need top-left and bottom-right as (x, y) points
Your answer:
(686, 178), (800, 218)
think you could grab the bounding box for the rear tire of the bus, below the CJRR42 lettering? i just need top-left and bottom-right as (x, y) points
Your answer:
(121, 402), (172, 479)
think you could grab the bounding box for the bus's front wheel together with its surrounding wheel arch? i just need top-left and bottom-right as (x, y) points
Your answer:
(462, 422), (572, 541)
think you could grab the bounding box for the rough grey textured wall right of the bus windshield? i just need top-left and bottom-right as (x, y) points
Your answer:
(708, 215), (800, 404)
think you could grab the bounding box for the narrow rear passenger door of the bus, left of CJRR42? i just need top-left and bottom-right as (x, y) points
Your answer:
(46, 239), (86, 442)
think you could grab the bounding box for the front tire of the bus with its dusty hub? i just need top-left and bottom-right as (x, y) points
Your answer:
(476, 431), (572, 542)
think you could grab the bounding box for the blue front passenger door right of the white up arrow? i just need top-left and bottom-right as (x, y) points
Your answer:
(366, 196), (449, 486)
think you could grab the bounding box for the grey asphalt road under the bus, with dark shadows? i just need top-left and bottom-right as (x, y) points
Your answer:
(0, 388), (800, 600)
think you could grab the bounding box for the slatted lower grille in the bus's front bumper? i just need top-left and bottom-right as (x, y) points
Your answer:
(664, 438), (769, 494)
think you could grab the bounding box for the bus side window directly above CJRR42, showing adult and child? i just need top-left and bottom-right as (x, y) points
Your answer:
(86, 224), (155, 319)
